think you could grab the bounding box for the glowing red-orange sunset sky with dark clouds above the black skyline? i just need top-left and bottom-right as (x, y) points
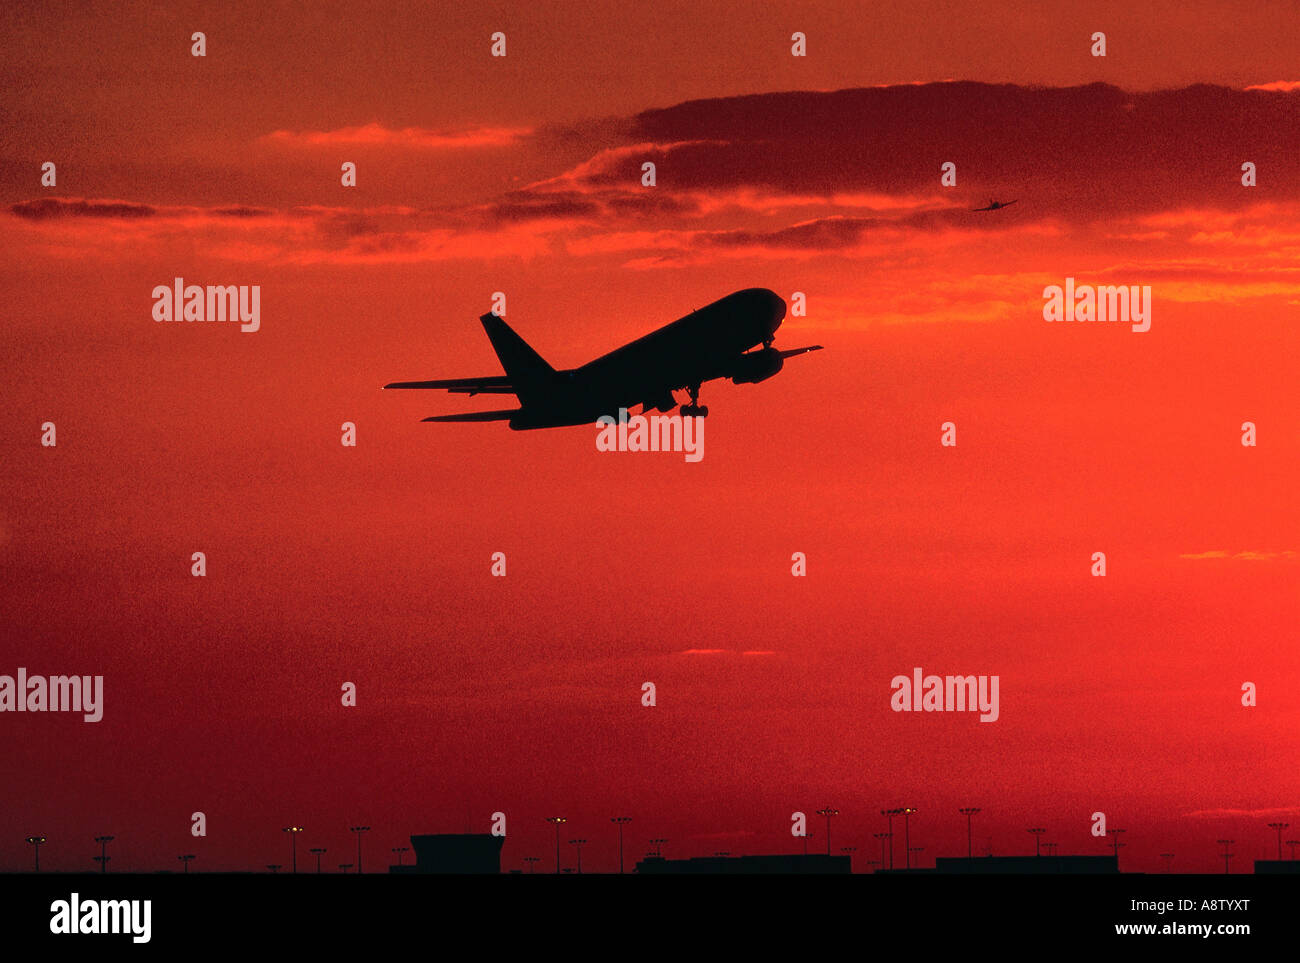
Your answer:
(0, 1), (1300, 872)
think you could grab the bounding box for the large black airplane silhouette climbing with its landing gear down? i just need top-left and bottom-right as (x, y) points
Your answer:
(384, 287), (822, 431)
